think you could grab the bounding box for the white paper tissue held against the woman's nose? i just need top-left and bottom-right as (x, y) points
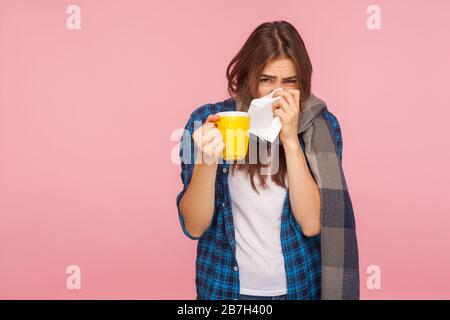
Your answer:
(248, 88), (283, 143)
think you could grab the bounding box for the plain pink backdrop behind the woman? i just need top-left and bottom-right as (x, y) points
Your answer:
(0, 0), (450, 299)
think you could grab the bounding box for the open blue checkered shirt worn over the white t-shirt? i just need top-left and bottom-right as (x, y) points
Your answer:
(176, 98), (342, 300)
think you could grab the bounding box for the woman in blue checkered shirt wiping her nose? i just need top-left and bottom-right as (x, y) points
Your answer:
(177, 21), (359, 300)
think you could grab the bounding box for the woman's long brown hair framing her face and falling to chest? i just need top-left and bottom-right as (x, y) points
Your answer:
(226, 21), (312, 193)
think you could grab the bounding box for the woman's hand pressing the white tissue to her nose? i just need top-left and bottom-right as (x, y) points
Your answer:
(272, 89), (300, 147)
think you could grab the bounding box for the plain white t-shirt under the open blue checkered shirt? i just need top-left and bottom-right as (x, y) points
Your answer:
(228, 167), (287, 296)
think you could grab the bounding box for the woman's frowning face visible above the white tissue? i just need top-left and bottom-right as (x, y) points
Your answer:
(258, 58), (299, 98)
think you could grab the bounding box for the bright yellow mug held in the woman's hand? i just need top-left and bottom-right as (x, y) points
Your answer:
(216, 111), (250, 161)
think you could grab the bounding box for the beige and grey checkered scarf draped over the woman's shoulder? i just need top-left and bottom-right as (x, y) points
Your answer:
(298, 94), (359, 300)
